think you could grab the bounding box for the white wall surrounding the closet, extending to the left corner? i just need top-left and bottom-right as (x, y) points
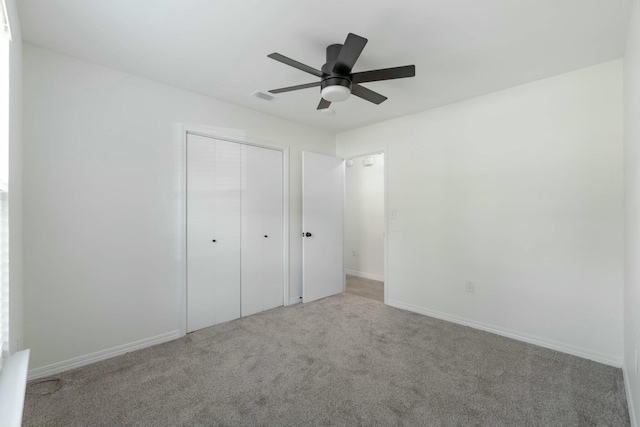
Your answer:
(23, 44), (335, 368)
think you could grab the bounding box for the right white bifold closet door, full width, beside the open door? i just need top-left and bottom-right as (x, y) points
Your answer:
(242, 146), (284, 316)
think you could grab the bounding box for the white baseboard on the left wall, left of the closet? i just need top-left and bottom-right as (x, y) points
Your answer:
(27, 331), (182, 380)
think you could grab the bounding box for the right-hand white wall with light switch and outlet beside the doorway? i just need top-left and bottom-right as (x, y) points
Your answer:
(337, 60), (623, 366)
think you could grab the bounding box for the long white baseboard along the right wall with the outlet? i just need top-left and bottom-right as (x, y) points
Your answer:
(387, 300), (622, 368)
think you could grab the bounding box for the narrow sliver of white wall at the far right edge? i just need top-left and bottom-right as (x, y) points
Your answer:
(624, 1), (640, 426)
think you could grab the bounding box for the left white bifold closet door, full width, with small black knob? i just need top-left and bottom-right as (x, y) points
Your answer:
(187, 135), (241, 332)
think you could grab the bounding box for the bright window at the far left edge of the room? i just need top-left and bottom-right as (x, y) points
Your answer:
(0, 0), (11, 369)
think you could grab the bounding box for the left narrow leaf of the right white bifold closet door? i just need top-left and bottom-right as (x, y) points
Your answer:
(242, 145), (268, 316)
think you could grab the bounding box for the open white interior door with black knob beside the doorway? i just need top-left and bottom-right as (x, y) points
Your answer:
(302, 152), (344, 302)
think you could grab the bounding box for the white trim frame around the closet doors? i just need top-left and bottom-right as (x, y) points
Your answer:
(174, 123), (290, 336)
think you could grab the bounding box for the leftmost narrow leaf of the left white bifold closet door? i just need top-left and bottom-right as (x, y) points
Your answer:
(187, 135), (216, 332)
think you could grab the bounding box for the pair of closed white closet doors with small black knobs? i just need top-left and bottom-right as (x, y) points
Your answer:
(187, 135), (284, 332)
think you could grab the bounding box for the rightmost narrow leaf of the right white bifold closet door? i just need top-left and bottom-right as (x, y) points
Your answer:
(261, 150), (284, 310)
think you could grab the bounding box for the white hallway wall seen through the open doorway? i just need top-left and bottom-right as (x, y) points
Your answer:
(344, 153), (384, 280)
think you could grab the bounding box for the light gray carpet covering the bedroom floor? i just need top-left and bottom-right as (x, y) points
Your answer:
(24, 293), (629, 427)
